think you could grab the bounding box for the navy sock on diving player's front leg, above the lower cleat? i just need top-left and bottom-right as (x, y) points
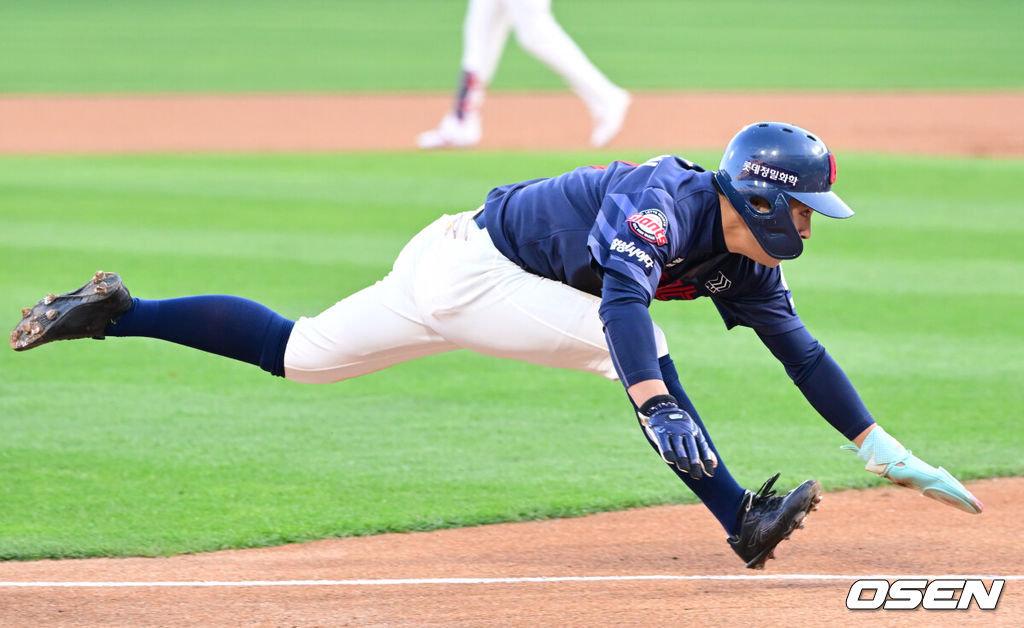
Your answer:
(655, 355), (746, 535)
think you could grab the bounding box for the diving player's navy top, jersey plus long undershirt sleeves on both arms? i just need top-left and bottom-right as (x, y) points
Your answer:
(477, 151), (872, 438)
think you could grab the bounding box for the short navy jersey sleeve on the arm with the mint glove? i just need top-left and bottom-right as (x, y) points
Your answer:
(712, 260), (804, 335)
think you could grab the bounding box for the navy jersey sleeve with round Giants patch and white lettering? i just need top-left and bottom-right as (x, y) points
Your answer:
(587, 187), (688, 303)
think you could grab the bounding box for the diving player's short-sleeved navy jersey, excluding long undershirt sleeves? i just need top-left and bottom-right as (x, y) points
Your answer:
(483, 156), (802, 334)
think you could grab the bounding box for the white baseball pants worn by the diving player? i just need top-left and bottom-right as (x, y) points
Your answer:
(285, 211), (668, 383)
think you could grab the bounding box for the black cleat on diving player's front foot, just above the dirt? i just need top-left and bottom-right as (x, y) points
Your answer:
(728, 473), (821, 570)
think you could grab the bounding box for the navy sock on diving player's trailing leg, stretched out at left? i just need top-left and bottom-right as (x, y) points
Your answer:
(105, 294), (295, 377)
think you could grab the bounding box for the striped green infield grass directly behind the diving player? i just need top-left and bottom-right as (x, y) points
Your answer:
(0, 153), (1024, 559)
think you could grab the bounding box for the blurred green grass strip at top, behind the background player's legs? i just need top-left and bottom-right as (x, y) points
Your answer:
(0, 0), (1024, 93)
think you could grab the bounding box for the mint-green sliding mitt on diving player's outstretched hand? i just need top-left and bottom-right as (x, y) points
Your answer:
(842, 425), (985, 514)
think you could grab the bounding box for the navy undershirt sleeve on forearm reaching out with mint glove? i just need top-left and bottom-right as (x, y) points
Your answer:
(758, 327), (874, 441)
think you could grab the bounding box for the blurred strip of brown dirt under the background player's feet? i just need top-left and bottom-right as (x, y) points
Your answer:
(6, 92), (1024, 156)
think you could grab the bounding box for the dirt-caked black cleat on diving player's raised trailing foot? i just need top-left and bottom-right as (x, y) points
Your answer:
(10, 270), (131, 351)
